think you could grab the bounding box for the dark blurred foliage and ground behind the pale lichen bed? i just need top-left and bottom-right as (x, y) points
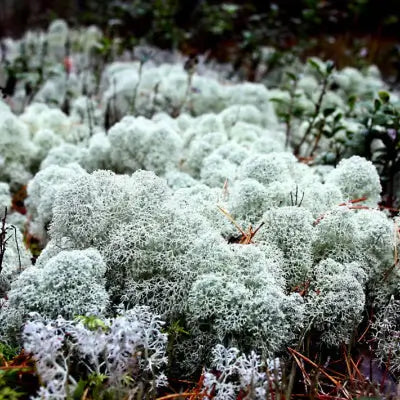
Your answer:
(0, 0), (400, 75)
